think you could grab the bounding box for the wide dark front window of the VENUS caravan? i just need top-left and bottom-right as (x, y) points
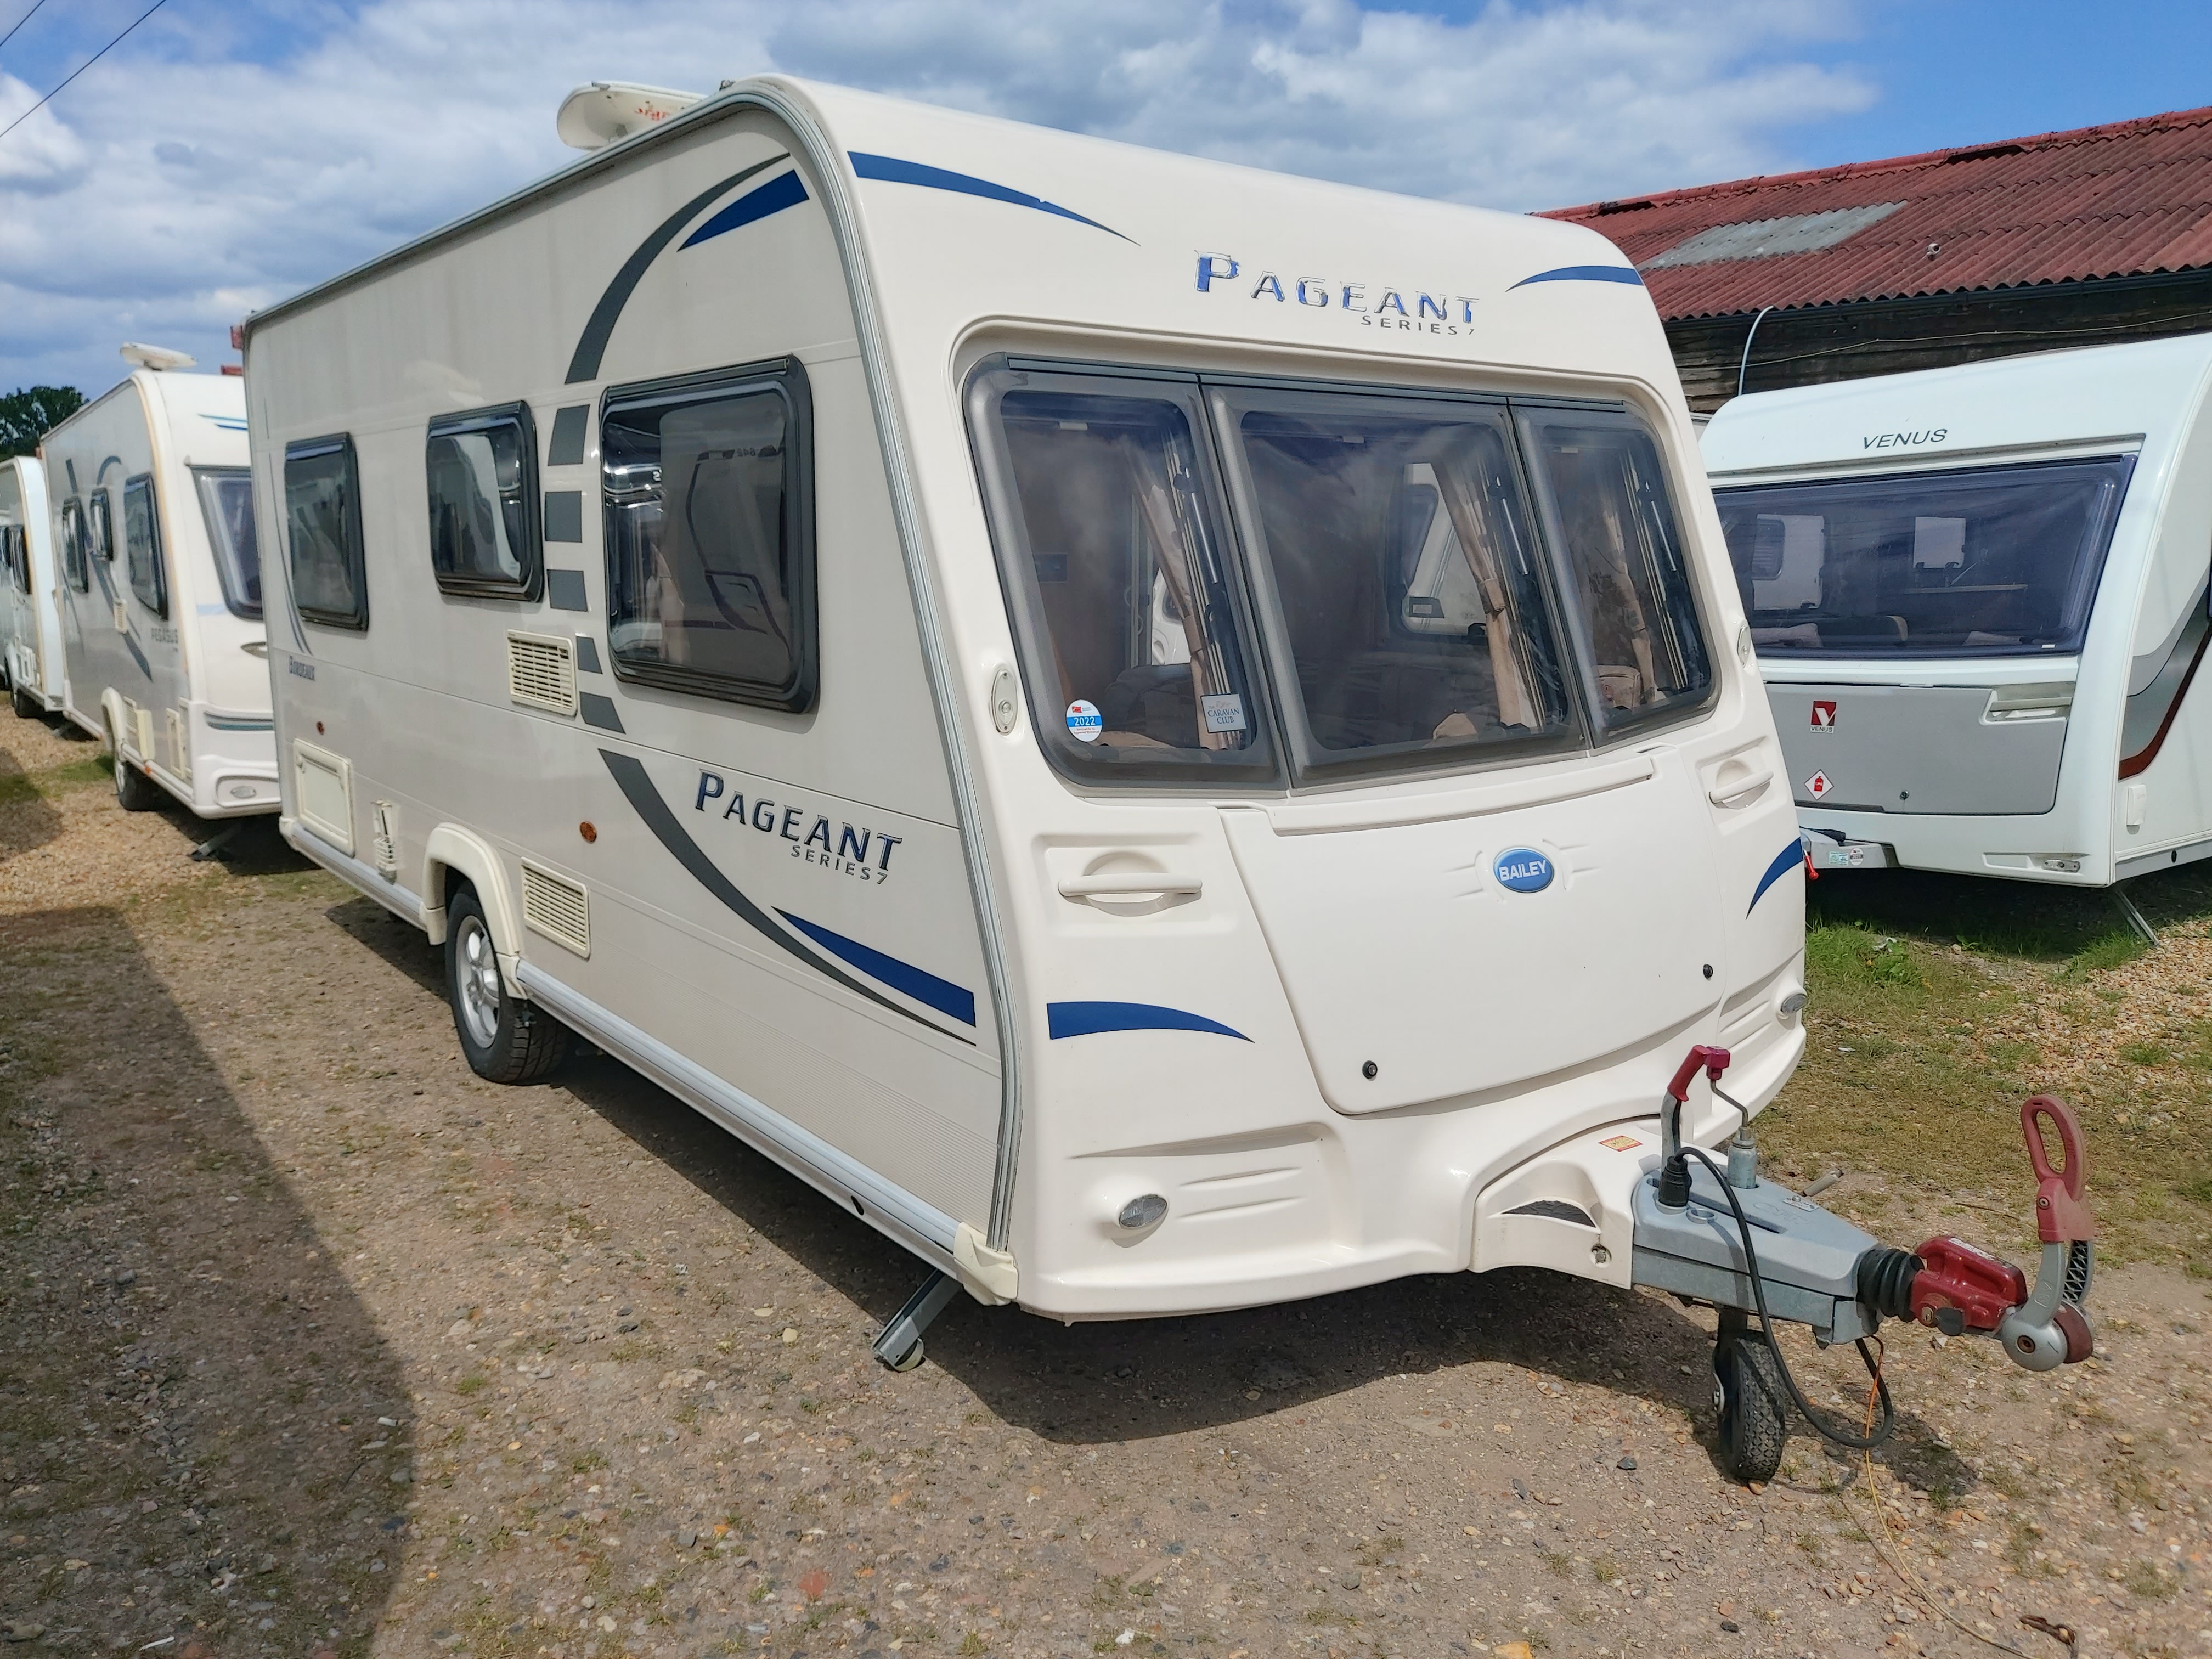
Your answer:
(1717, 456), (2135, 657)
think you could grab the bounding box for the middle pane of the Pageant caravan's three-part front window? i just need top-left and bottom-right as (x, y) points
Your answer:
(1219, 392), (1579, 772)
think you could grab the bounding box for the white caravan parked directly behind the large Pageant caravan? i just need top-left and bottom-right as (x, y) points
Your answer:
(40, 345), (279, 819)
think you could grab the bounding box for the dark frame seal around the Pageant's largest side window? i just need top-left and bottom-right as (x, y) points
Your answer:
(595, 356), (821, 714)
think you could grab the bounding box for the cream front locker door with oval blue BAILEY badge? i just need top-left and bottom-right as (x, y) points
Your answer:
(1223, 750), (1728, 1113)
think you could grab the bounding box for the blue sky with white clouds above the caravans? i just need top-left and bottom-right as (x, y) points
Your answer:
(0, 0), (2212, 392)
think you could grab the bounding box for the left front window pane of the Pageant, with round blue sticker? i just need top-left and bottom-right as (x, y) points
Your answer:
(973, 369), (1274, 781)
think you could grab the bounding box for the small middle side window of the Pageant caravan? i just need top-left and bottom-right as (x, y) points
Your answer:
(425, 403), (544, 600)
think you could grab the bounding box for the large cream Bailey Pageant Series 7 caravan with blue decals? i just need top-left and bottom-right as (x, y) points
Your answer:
(246, 77), (1803, 1361)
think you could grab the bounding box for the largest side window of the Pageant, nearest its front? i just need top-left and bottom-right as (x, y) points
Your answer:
(600, 360), (816, 710)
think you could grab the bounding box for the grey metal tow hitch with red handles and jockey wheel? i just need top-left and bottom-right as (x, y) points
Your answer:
(1630, 1046), (2097, 1482)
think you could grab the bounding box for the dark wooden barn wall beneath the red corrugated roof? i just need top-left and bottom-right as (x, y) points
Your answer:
(1666, 270), (2212, 411)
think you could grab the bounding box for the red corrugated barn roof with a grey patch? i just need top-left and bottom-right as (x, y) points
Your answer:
(1542, 109), (2212, 319)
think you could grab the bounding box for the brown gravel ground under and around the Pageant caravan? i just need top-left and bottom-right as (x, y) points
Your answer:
(0, 712), (2212, 1659)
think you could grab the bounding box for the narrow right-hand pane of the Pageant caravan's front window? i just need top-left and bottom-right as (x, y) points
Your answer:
(1522, 409), (1712, 732)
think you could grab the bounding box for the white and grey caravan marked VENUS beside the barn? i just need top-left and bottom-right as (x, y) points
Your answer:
(1703, 334), (2212, 887)
